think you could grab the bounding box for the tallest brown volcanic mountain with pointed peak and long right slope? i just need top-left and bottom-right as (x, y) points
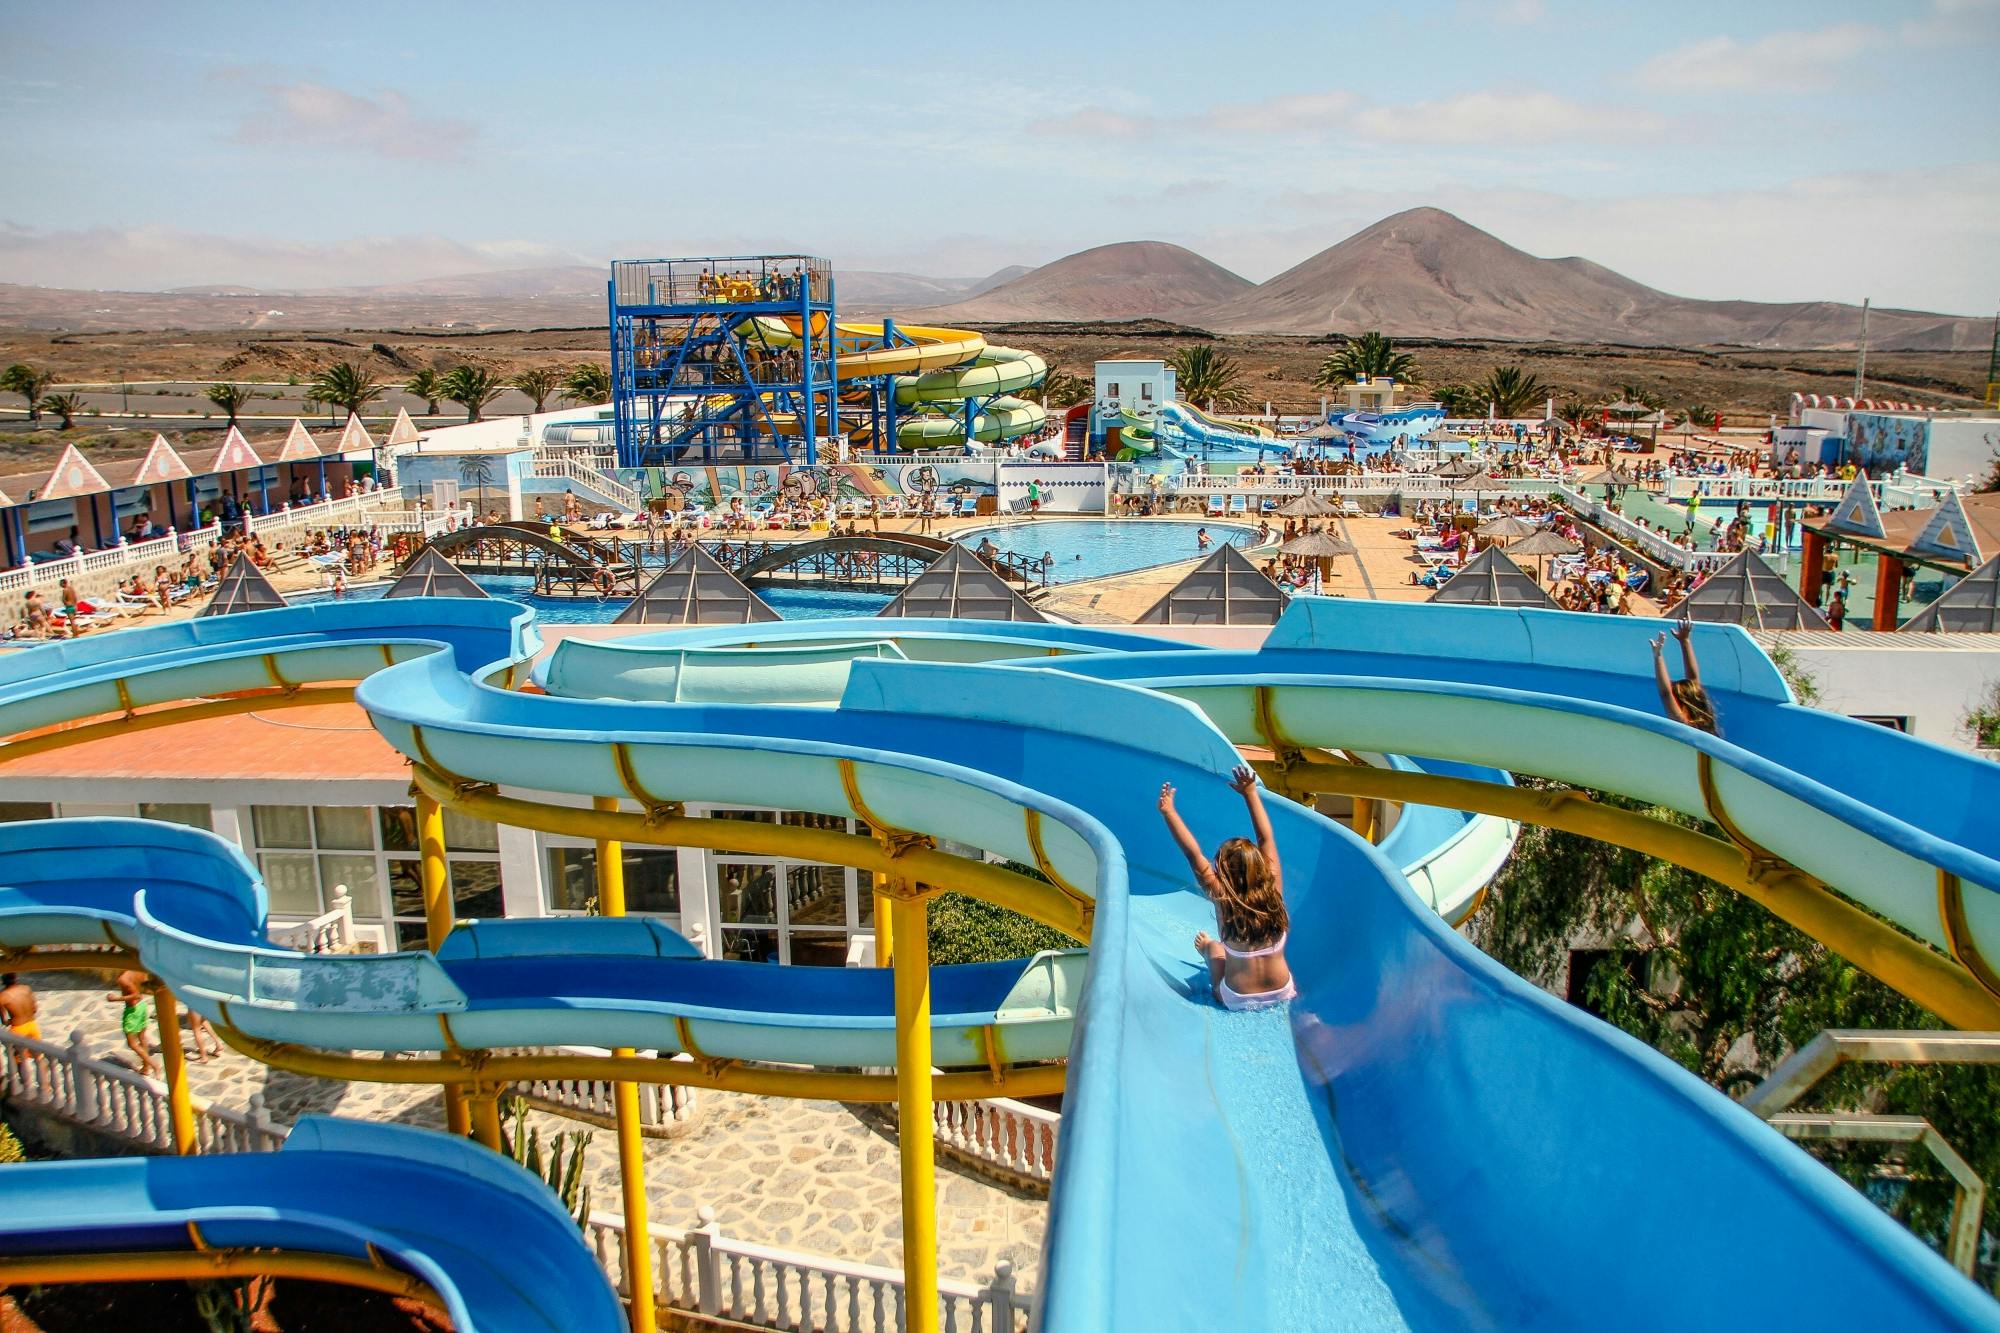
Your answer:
(1172, 208), (1990, 350)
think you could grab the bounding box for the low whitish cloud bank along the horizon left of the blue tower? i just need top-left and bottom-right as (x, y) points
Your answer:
(0, 222), (584, 290)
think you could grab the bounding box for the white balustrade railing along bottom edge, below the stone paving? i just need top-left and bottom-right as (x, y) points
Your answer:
(588, 1207), (1030, 1333)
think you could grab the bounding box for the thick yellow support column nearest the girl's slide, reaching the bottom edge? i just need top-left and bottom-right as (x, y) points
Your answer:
(888, 881), (938, 1333)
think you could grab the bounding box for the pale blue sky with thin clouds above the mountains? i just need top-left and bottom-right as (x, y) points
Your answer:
(0, 0), (2000, 314)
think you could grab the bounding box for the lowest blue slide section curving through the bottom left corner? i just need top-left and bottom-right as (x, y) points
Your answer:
(0, 1115), (626, 1333)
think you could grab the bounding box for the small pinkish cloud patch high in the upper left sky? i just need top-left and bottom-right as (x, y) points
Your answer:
(216, 68), (478, 166)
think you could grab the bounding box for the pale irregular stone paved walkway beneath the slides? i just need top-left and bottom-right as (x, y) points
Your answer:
(32, 973), (1048, 1287)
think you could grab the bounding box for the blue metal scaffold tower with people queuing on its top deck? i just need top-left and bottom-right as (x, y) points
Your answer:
(606, 254), (840, 466)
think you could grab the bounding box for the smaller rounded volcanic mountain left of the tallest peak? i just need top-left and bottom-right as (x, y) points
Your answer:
(906, 240), (1250, 324)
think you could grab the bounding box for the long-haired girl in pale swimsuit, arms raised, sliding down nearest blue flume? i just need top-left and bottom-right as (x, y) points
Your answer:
(1160, 765), (1298, 1009)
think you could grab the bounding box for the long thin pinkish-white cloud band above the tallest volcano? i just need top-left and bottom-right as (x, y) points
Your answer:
(1028, 90), (1666, 144)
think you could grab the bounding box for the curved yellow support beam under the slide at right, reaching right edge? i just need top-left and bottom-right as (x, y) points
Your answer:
(1254, 763), (2000, 1031)
